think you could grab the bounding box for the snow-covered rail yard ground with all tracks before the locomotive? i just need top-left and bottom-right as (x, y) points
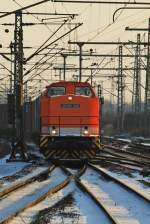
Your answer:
(0, 139), (150, 224)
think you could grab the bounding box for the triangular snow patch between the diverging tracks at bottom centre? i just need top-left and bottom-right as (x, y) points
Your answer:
(11, 182), (112, 224)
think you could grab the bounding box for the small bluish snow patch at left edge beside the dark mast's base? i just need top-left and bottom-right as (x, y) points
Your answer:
(0, 155), (29, 178)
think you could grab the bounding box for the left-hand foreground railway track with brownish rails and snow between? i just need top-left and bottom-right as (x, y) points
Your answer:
(0, 167), (71, 223)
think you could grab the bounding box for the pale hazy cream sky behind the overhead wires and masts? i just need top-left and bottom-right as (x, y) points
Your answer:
(0, 0), (150, 101)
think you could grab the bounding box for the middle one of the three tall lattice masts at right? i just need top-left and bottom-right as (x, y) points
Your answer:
(132, 34), (141, 113)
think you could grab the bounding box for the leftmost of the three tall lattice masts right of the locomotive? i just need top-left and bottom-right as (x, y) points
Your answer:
(117, 46), (124, 132)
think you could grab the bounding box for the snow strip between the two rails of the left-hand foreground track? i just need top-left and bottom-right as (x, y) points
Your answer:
(0, 168), (66, 222)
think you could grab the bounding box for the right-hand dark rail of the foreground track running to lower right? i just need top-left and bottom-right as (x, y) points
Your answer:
(88, 163), (150, 202)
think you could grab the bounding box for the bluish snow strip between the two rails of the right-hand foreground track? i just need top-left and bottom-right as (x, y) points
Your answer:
(82, 169), (150, 224)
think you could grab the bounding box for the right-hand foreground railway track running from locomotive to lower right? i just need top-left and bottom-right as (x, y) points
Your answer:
(61, 164), (149, 224)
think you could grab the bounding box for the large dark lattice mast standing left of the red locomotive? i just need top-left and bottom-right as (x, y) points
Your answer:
(10, 10), (27, 160)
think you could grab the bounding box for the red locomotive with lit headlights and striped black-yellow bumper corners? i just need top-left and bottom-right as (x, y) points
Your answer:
(40, 81), (100, 160)
